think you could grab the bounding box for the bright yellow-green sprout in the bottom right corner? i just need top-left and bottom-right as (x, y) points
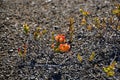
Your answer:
(103, 61), (117, 77)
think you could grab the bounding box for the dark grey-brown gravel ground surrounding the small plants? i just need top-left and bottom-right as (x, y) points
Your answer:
(0, 0), (120, 80)
